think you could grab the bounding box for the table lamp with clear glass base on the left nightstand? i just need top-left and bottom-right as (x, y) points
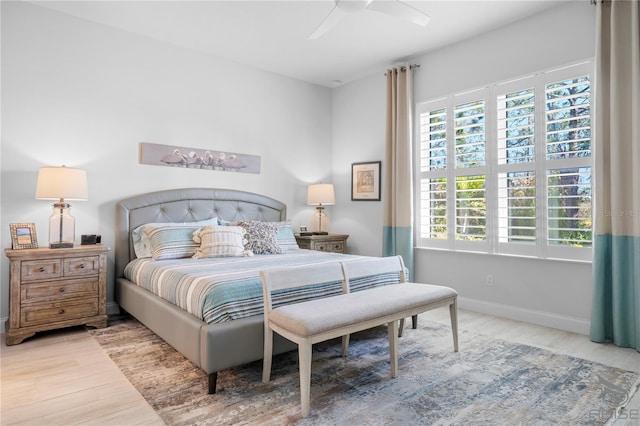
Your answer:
(36, 166), (88, 249)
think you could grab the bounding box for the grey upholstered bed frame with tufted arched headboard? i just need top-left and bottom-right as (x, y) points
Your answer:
(115, 188), (296, 393)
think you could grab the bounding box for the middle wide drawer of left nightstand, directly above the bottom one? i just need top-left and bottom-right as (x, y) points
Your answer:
(20, 279), (99, 306)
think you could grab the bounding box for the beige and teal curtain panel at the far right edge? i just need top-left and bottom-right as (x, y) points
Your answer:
(590, 0), (640, 351)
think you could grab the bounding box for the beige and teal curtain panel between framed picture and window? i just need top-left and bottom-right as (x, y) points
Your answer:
(382, 64), (413, 279)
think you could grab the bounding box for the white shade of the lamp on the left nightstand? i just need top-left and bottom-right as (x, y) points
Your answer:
(36, 166), (89, 201)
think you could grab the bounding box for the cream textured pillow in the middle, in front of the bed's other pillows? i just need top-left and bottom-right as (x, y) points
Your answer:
(193, 226), (253, 259)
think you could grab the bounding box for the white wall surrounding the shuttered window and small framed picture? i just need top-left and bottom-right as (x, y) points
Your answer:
(333, 2), (595, 333)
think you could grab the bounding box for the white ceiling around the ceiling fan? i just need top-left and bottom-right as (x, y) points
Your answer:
(33, 0), (568, 87)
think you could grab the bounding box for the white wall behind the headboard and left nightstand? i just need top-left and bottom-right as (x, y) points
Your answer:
(0, 2), (332, 325)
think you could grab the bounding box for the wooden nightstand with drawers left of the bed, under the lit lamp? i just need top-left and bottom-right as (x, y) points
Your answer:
(5, 244), (109, 345)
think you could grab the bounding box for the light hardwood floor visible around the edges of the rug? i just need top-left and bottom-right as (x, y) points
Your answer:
(0, 309), (640, 426)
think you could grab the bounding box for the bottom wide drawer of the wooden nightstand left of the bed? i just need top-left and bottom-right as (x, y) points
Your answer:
(20, 298), (98, 327)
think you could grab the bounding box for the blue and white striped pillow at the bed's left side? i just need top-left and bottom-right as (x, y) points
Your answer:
(144, 224), (201, 260)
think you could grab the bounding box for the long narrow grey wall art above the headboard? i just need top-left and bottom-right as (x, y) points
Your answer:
(140, 142), (260, 174)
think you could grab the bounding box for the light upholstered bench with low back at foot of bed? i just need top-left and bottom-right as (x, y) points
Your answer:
(261, 256), (458, 417)
